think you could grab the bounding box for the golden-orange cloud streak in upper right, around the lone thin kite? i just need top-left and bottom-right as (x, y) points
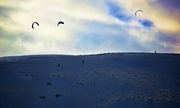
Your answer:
(114, 0), (180, 33)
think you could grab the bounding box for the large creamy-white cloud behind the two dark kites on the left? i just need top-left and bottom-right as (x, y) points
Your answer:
(2, 0), (114, 54)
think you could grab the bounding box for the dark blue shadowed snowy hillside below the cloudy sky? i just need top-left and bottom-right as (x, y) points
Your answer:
(0, 53), (180, 108)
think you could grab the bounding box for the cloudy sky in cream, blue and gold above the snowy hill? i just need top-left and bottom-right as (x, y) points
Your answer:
(0, 0), (180, 56)
